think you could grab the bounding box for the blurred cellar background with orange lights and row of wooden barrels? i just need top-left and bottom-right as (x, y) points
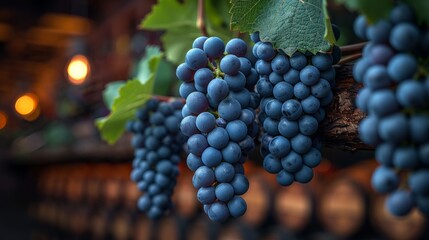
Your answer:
(0, 0), (429, 240)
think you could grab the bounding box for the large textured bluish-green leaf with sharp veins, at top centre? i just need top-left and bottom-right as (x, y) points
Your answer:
(230, 0), (335, 55)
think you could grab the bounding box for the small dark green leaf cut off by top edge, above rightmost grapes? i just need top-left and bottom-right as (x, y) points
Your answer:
(335, 0), (392, 23)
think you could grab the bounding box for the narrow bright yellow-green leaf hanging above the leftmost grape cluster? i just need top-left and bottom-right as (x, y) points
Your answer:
(95, 48), (162, 144)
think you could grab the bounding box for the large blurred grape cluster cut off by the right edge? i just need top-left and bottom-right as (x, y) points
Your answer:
(353, 4), (429, 216)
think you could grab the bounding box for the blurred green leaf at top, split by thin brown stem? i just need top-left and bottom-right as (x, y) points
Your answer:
(140, 0), (232, 65)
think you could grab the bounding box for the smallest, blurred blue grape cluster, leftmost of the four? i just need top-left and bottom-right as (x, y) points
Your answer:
(127, 99), (186, 219)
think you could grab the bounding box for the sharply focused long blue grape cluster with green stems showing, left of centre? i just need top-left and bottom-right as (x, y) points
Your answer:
(176, 37), (259, 221)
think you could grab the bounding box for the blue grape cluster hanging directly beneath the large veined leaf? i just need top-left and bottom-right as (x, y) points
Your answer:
(251, 26), (341, 186)
